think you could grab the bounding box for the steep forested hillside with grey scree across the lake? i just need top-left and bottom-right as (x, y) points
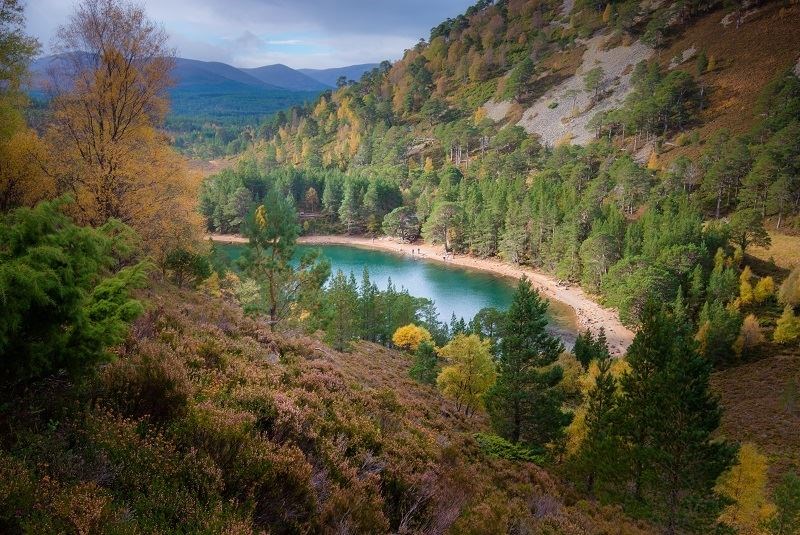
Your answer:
(197, 0), (800, 529)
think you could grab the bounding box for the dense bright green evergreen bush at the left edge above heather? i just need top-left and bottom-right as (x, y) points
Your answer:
(0, 200), (149, 381)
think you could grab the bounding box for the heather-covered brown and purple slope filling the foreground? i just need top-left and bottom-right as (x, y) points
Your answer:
(0, 283), (650, 534)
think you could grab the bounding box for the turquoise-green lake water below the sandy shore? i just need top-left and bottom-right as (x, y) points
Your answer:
(218, 245), (575, 345)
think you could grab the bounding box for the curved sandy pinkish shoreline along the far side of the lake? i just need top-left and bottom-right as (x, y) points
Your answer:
(208, 234), (634, 355)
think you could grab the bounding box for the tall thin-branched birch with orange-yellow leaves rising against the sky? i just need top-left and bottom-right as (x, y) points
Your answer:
(47, 0), (199, 260)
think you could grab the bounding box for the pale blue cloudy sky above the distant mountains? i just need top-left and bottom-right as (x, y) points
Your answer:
(26, 0), (475, 69)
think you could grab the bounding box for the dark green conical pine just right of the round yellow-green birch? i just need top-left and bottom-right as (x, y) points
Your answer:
(486, 278), (570, 446)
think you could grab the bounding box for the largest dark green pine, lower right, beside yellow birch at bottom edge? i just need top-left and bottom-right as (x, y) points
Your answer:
(619, 304), (734, 533)
